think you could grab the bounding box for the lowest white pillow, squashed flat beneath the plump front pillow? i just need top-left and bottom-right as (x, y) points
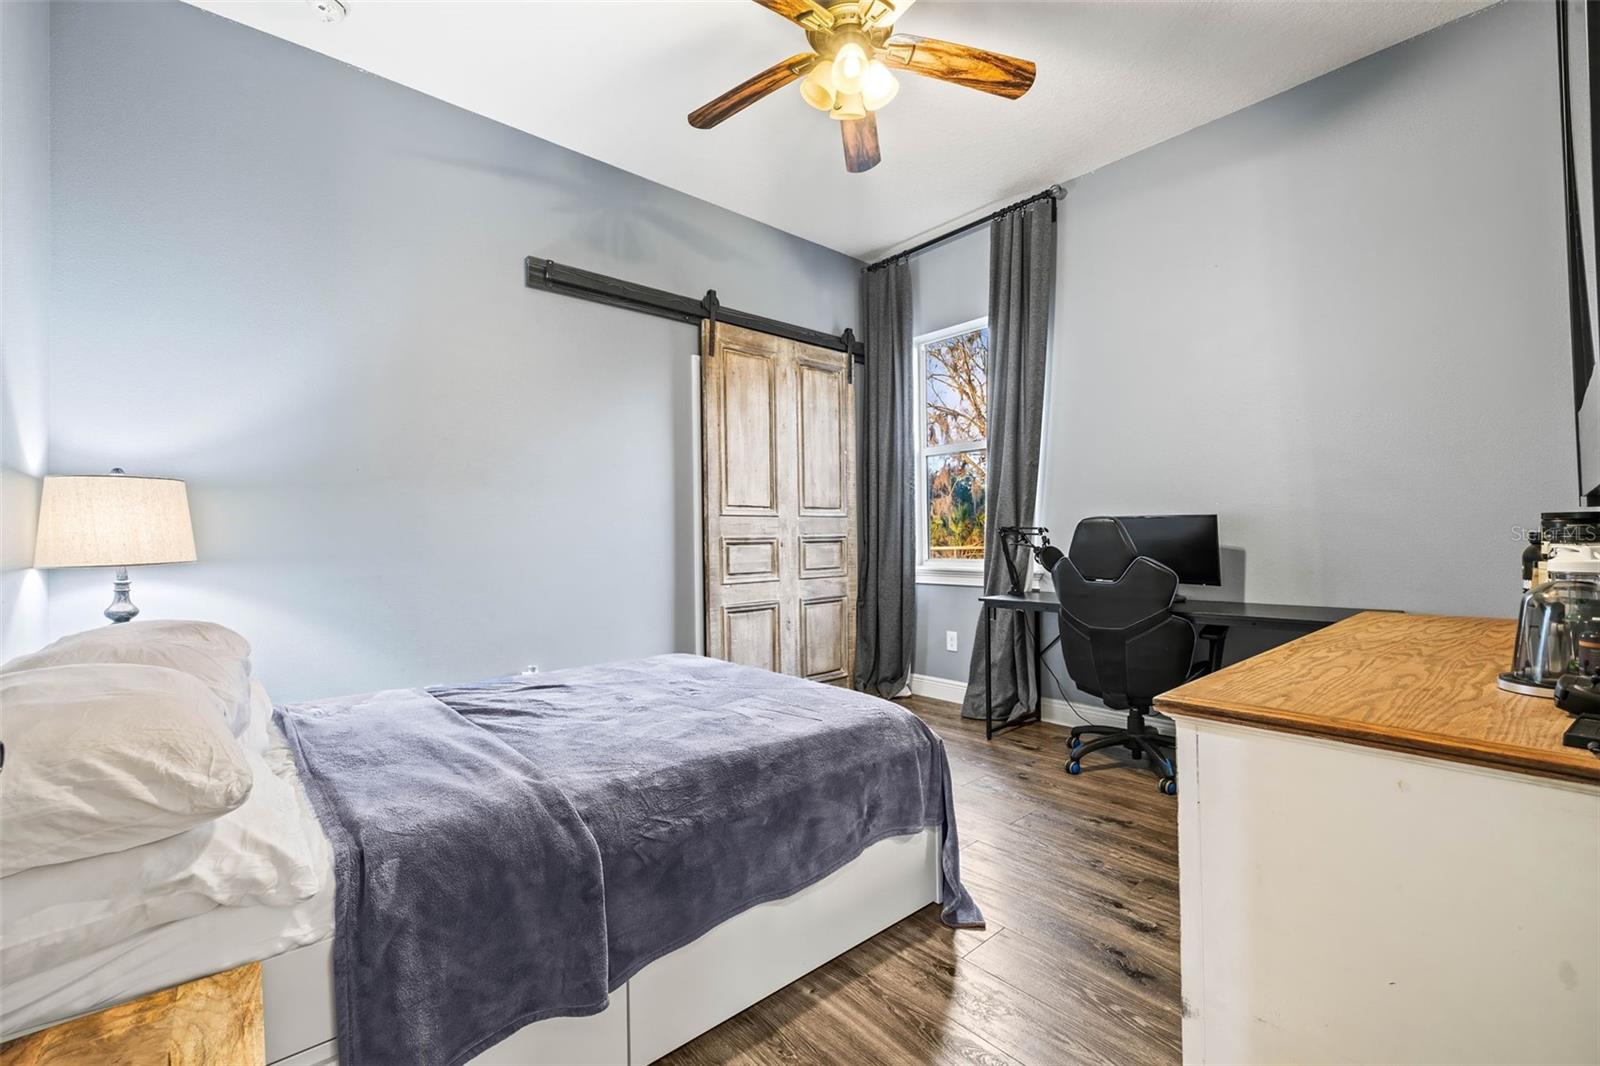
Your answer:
(0, 739), (322, 981)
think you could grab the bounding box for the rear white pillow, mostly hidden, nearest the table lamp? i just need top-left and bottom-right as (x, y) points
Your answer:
(0, 619), (250, 736)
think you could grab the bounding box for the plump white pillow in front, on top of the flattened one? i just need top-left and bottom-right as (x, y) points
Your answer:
(0, 663), (251, 877)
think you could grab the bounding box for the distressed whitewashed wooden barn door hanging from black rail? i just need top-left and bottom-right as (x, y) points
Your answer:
(701, 323), (856, 683)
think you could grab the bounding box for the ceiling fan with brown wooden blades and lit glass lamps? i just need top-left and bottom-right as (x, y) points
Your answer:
(690, 0), (1037, 174)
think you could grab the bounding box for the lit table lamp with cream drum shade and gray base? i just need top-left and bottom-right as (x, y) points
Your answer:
(34, 467), (195, 623)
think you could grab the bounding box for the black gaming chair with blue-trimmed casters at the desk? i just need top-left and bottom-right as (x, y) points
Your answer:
(1050, 519), (1205, 795)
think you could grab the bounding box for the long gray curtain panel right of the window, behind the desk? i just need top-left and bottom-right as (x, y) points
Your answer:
(962, 200), (1056, 719)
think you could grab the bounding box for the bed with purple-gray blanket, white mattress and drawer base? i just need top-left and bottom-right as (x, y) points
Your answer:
(0, 640), (981, 1066)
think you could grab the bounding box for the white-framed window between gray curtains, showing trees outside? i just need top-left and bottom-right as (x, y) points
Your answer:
(912, 319), (989, 583)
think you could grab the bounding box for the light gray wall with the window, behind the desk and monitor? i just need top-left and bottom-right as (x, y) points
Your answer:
(917, 3), (1576, 677)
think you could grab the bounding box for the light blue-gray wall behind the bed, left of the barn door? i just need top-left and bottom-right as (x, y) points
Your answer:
(50, 3), (859, 698)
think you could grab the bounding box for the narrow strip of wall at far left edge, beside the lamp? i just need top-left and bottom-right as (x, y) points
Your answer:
(0, 2), (50, 659)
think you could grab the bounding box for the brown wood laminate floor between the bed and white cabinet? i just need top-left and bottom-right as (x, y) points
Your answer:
(662, 698), (1179, 1066)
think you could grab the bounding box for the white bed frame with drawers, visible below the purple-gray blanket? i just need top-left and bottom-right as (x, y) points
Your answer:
(261, 829), (939, 1066)
